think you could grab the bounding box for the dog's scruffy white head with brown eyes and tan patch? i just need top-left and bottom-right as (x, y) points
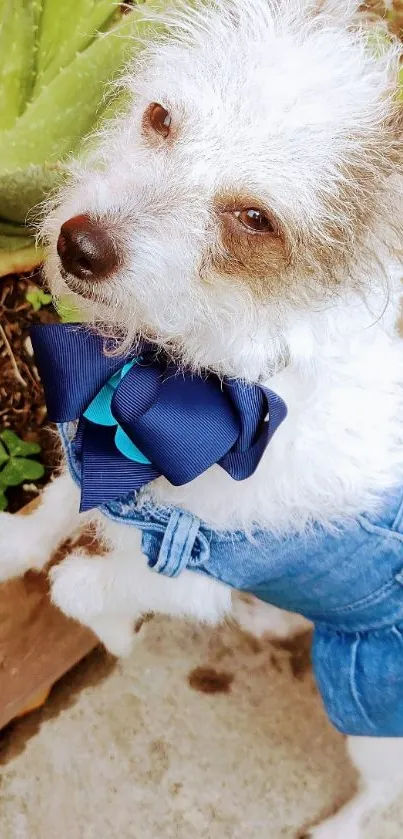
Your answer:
(44, 0), (401, 378)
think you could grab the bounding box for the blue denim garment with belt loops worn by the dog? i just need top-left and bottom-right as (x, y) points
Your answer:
(60, 426), (403, 737)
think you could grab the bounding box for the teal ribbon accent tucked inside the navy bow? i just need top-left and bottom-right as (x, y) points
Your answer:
(84, 358), (151, 463)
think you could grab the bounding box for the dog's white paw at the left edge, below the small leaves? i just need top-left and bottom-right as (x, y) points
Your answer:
(0, 513), (50, 582)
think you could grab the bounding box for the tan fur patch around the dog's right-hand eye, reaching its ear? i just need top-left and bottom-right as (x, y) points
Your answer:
(210, 82), (403, 305)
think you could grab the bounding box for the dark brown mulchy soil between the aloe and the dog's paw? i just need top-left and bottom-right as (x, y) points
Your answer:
(0, 271), (59, 512)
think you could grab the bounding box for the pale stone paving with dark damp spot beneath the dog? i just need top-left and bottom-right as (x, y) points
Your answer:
(0, 618), (403, 839)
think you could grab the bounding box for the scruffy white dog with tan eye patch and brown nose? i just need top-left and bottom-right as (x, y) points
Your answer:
(0, 0), (403, 839)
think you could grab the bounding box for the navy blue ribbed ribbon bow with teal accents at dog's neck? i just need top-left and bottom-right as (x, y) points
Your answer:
(31, 324), (287, 510)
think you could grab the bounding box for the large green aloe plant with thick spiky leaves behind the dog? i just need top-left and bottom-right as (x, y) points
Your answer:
(0, 0), (165, 276)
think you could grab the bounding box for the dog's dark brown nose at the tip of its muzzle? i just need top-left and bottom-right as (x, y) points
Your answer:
(57, 215), (118, 282)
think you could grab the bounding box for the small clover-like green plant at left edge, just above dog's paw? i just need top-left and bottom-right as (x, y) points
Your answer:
(0, 428), (45, 510)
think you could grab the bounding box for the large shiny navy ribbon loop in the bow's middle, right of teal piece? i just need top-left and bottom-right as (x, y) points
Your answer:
(112, 364), (240, 486)
